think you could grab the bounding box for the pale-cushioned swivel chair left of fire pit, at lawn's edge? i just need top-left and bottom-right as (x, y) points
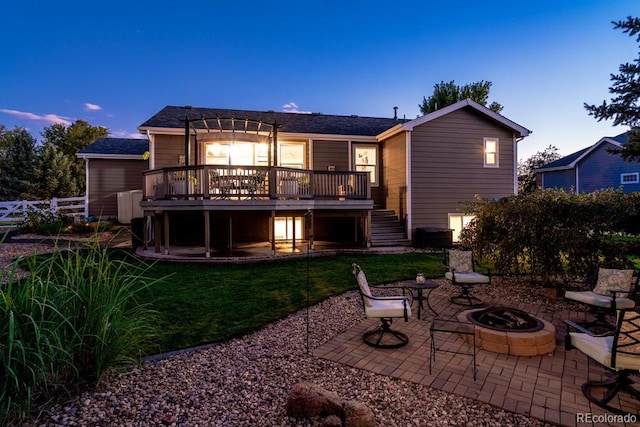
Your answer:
(352, 264), (411, 348)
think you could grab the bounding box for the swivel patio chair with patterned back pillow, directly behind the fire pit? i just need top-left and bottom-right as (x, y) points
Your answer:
(444, 249), (491, 306)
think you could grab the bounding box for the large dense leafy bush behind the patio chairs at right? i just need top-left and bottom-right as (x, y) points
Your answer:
(462, 190), (640, 283)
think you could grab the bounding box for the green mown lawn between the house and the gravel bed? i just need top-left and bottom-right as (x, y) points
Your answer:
(142, 253), (444, 354)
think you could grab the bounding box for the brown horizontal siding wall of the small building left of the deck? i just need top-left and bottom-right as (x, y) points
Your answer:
(89, 159), (149, 218)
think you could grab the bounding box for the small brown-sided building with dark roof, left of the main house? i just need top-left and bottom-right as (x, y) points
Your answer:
(76, 138), (149, 218)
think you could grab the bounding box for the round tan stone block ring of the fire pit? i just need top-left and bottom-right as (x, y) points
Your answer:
(457, 308), (556, 356)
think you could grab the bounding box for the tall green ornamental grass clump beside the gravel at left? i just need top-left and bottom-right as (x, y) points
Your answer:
(0, 234), (158, 424)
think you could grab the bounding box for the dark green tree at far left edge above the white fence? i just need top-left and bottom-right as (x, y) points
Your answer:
(0, 127), (37, 200)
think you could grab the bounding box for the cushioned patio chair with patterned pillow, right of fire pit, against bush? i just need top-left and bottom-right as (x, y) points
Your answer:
(564, 267), (640, 330)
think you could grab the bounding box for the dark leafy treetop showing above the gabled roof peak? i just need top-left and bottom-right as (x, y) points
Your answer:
(418, 80), (503, 114)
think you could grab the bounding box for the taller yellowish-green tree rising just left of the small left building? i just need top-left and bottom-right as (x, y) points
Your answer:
(42, 120), (109, 196)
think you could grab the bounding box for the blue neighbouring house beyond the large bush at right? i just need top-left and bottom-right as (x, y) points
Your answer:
(536, 133), (640, 193)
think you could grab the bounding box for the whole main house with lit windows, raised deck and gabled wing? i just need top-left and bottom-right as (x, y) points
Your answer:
(131, 99), (530, 257)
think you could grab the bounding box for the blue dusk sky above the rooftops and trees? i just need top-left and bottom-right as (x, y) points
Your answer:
(0, 0), (640, 159)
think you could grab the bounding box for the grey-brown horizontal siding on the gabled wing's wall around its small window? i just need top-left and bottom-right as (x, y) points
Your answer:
(411, 109), (515, 228)
